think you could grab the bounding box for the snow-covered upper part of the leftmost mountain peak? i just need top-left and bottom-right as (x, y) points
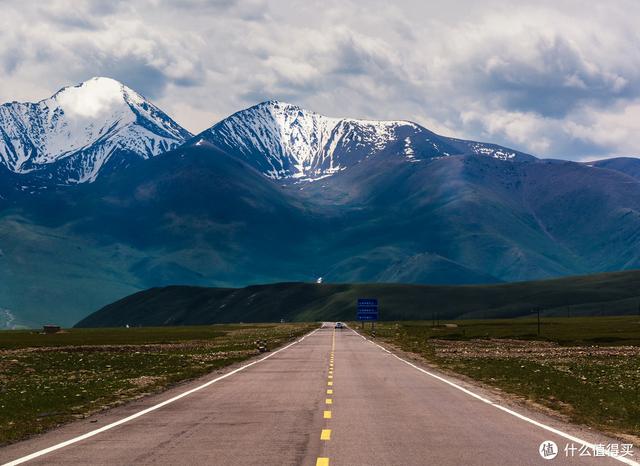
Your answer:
(0, 77), (191, 184)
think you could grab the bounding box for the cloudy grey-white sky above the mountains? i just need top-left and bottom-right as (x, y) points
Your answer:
(0, 0), (640, 160)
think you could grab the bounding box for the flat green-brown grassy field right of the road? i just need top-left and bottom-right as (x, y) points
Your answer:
(364, 317), (640, 444)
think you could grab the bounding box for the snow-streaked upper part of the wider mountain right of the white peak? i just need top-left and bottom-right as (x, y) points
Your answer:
(193, 100), (534, 180)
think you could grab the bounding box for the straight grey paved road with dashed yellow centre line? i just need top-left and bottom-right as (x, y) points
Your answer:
(0, 327), (633, 466)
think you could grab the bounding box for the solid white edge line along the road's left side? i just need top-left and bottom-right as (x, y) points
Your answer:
(2, 329), (320, 466)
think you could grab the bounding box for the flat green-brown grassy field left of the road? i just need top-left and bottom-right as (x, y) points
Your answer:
(0, 324), (315, 445)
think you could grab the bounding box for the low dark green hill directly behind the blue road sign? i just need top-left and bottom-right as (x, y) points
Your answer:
(75, 270), (640, 328)
